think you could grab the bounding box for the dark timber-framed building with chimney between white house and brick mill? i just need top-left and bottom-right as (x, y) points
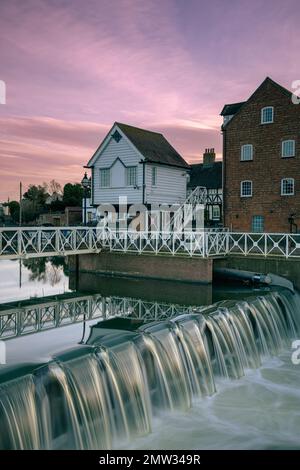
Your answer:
(188, 148), (222, 226)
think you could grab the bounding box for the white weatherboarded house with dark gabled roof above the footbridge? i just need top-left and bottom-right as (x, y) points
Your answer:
(87, 122), (189, 210)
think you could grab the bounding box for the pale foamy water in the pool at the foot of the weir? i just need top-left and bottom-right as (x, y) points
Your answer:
(124, 352), (300, 450)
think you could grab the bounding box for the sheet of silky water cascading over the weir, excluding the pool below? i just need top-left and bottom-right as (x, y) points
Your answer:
(0, 291), (300, 449)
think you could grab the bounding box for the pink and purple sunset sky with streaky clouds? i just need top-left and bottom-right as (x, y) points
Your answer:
(0, 0), (300, 201)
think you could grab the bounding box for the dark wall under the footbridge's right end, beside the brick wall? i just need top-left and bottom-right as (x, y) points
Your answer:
(214, 256), (300, 289)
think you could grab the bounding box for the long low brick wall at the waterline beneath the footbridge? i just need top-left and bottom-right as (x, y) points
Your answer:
(70, 252), (213, 284)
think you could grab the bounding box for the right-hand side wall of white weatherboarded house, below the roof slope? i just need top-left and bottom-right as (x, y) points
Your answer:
(145, 164), (187, 204)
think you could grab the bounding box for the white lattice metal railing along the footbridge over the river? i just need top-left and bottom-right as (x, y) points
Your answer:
(0, 227), (300, 259)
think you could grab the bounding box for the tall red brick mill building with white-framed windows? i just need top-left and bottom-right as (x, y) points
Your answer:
(221, 77), (300, 232)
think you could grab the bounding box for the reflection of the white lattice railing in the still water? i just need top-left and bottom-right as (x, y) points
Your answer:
(0, 294), (195, 339)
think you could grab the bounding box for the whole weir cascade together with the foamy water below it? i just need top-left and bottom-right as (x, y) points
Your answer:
(0, 291), (300, 449)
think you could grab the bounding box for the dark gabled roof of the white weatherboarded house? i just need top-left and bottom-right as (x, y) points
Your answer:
(87, 122), (189, 169)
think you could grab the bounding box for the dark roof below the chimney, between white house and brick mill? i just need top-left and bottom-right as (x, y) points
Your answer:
(188, 161), (222, 189)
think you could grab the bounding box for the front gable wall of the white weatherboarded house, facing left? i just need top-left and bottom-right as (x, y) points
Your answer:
(93, 133), (143, 205)
